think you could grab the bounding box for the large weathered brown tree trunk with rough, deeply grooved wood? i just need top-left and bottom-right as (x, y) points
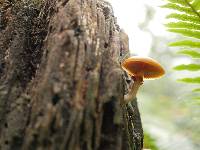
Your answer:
(0, 0), (143, 150)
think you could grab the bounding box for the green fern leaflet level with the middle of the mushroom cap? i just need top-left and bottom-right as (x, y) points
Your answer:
(174, 64), (200, 71)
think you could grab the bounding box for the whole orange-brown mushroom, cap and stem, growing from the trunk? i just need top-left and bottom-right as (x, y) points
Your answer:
(122, 56), (165, 104)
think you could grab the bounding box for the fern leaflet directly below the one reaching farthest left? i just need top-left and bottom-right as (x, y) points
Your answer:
(166, 13), (200, 24)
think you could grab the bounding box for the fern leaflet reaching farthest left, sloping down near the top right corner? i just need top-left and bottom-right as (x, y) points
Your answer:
(161, 3), (196, 16)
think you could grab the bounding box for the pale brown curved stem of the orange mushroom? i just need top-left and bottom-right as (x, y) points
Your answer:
(124, 77), (143, 104)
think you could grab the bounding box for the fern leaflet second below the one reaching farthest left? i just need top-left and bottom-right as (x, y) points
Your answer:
(165, 21), (200, 30)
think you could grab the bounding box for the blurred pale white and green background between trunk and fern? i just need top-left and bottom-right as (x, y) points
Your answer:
(107, 0), (200, 150)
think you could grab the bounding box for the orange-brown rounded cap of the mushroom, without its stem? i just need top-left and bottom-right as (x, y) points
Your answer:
(122, 56), (165, 79)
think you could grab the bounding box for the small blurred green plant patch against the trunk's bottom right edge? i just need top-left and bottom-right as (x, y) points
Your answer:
(144, 132), (159, 150)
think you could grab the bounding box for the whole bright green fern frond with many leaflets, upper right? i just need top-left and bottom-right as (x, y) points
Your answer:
(161, 0), (200, 99)
